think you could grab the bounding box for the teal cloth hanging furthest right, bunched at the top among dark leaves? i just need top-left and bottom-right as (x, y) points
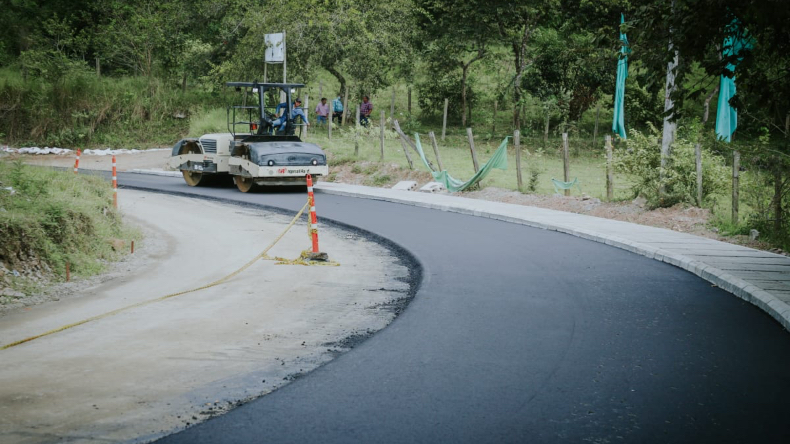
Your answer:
(716, 21), (752, 142)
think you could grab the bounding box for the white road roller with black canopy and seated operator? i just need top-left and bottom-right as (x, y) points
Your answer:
(169, 82), (329, 193)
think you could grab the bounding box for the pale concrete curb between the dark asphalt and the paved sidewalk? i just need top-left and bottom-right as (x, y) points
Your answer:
(316, 186), (790, 331)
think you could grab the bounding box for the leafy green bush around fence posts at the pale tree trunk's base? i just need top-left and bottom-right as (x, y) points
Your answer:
(614, 125), (728, 208)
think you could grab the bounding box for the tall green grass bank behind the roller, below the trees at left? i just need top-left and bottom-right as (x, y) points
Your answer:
(0, 67), (225, 148)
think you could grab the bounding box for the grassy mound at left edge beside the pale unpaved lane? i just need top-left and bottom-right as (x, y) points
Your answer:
(0, 161), (141, 288)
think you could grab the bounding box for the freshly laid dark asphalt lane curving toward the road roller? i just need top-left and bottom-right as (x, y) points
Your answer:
(119, 174), (790, 443)
